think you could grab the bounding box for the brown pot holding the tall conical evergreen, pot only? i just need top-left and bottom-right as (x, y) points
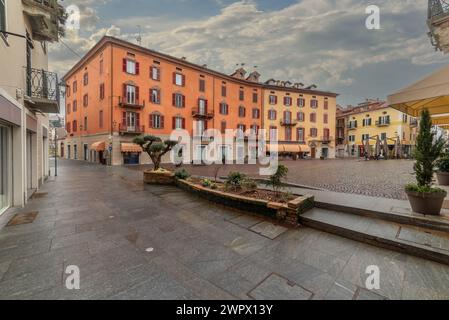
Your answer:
(406, 191), (447, 216)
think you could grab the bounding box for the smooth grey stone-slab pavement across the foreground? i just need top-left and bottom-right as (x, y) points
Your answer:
(0, 161), (449, 300)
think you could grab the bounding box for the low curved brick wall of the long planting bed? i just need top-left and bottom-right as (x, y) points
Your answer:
(176, 180), (315, 226)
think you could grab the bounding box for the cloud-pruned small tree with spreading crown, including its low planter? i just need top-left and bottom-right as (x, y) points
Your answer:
(134, 136), (178, 184)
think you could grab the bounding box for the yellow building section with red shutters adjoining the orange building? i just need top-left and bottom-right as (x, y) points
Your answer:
(263, 82), (337, 158)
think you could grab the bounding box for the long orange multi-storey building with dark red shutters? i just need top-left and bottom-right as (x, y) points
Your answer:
(63, 37), (336, 165)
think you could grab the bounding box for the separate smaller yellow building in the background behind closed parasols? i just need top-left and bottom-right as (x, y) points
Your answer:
(337, 100), (418, 157)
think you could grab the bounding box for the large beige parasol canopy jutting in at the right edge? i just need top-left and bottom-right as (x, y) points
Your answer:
(388, 65), (449, 124)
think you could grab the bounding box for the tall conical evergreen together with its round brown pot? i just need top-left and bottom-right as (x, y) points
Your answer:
(406, 110), (447, 215)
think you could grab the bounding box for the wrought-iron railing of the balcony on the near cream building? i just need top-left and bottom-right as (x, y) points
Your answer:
(25, 67), (59, 102)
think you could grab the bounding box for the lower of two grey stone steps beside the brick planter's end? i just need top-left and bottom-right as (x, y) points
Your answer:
(300, 208), (449, 265)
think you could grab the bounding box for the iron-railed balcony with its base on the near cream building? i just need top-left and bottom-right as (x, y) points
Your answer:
(25, 68), (59, 113)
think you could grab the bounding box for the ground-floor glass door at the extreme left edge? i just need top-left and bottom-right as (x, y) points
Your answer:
(0, 125), (11, 214)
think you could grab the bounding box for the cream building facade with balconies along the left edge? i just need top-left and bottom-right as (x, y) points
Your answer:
(0, 0), (63, 213)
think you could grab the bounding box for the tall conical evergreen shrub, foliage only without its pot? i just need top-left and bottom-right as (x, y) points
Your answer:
(408, 109), (445, 192)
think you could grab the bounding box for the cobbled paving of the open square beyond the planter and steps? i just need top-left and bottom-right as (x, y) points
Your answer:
(131, 159), (414, 200)
